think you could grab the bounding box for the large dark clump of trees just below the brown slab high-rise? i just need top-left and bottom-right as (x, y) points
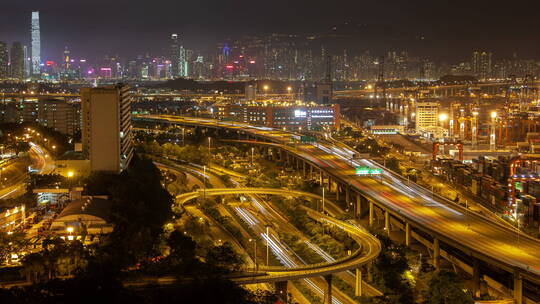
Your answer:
(87, 157), (173, 269)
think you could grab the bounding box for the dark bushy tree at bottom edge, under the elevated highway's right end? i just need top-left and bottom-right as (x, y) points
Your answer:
(425, 270), (474, 304)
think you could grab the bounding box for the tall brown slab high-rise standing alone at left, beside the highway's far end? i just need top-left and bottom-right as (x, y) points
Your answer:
(81, 84), (133, 172)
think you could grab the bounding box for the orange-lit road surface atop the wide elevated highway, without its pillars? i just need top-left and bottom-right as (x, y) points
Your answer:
(138, 115), (540, 288)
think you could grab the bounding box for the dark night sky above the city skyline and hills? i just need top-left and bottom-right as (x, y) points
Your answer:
(0, 0), (540, 60)
